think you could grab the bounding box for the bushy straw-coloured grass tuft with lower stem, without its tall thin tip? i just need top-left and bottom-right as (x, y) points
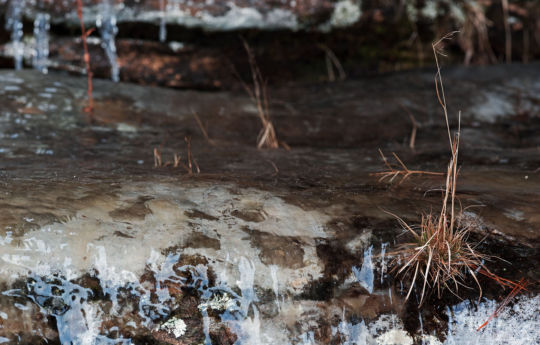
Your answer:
(393, 132), (489, 305)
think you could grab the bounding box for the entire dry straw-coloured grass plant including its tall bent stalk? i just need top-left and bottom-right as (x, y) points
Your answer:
(386, 33), (519, 305)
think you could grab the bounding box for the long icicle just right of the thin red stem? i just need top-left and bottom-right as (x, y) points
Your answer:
(96, 0), (120, 82)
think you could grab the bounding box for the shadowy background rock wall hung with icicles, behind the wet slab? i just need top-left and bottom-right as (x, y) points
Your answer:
(0, 0), (540, 90)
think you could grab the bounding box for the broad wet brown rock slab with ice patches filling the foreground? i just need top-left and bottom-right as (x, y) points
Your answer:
(0, 64), (540, 344)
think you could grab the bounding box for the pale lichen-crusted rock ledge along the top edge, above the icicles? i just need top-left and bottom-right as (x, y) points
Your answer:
(4, 0), (362, 31)
